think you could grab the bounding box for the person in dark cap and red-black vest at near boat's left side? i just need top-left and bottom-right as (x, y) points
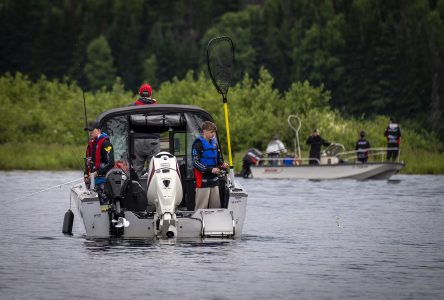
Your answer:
(84, 122), (114, 205)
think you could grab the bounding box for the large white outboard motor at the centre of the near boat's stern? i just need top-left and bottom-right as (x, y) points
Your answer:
(148, 152), (183, 238)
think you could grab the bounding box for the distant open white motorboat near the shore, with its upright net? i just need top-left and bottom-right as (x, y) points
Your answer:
(246, 115), (405, 180)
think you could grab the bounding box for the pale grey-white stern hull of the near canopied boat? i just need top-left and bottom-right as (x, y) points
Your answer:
(71, 183), (248, 239)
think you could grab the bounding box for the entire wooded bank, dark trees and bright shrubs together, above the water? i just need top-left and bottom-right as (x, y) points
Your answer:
(0, 0), (444, 173)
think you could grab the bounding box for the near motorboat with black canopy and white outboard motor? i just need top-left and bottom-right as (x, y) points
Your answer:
(71, 104), (248, 239)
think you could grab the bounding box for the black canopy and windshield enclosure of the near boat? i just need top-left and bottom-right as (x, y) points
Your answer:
(102, 112), (219, 178)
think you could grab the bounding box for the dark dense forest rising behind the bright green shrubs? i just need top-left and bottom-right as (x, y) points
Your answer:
(0, 0), (444, 136)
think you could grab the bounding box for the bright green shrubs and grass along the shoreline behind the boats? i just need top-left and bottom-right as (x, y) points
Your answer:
(0, 69), (444, 174)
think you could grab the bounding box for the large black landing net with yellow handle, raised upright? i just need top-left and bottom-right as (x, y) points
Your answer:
(207, 36), (234, 182)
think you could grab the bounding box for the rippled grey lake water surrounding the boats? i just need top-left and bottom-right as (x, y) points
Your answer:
(0, 171), (444, 299)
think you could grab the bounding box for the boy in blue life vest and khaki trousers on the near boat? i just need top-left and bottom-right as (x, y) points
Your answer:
(191, 121), (228, 210)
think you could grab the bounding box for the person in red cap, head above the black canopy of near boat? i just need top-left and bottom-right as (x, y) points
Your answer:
(130, 83), (160, 177)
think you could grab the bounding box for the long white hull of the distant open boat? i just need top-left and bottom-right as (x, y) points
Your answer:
(251, 162), (404, 180)
